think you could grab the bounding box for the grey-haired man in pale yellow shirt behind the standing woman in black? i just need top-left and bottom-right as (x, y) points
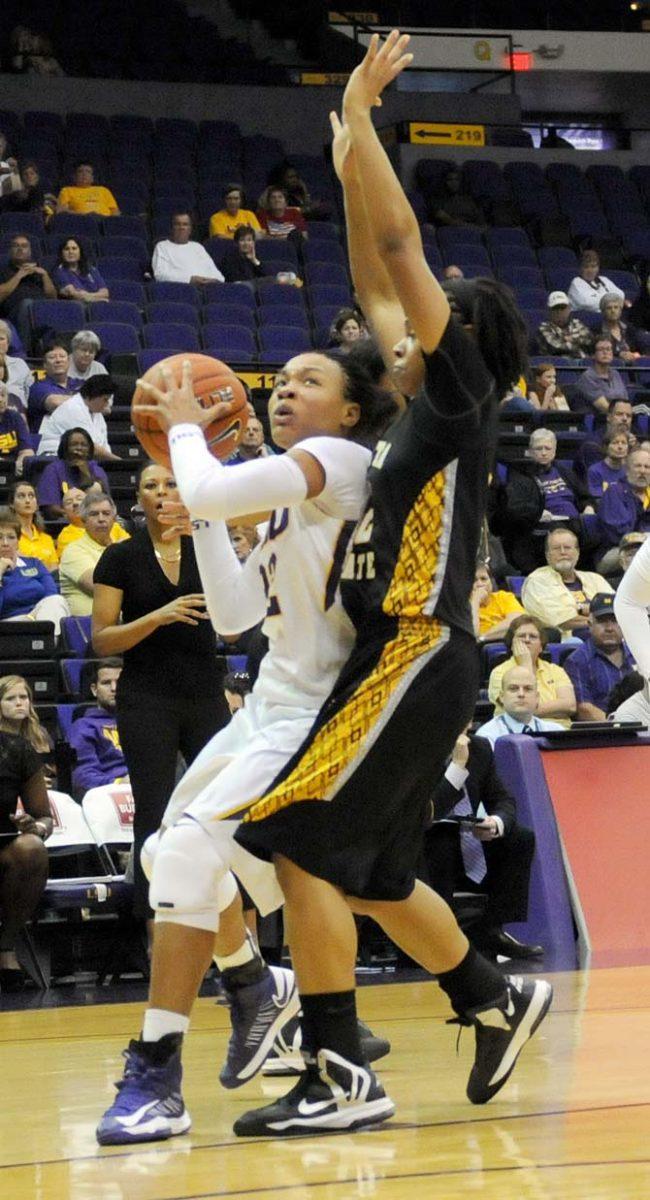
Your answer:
(59, 492), (125, 617)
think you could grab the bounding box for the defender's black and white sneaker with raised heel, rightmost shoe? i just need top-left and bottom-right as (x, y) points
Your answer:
(461, 976), (553, 1104)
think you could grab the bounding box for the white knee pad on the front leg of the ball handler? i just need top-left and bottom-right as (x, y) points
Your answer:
(149, 817), (235, 932)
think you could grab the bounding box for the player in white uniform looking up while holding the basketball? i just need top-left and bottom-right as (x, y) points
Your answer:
(97, 353), (395, 1145)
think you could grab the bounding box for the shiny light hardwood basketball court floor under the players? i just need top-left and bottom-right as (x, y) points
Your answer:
(0, 967), (650, 1200)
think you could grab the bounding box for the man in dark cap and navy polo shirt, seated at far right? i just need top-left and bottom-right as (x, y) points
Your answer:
(564, 593), (634, 721)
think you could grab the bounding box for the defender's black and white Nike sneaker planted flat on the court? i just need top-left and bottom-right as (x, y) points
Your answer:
(233, 1050), (395, 1138)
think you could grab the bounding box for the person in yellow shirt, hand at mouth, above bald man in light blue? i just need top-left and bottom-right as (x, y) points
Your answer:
(488, 612), (576, 725)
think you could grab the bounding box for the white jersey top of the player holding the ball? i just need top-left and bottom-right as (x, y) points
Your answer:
(251, 437), (371, 709)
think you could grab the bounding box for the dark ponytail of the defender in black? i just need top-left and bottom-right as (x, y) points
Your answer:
(473, 278), (528, 400)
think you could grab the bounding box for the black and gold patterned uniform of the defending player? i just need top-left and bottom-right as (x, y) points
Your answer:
(236, 318), (496, 900)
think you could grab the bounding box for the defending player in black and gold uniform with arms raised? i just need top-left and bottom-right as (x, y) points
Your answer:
(235, 32), (552, 1136)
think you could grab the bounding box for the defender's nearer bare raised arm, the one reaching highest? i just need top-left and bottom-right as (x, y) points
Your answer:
(343, 30), (450, 354)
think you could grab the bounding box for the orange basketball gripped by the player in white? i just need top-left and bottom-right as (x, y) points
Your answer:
(131, 354), (248, 468)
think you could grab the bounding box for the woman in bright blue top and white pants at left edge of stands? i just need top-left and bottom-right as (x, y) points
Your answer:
(0, 508), (70, 635)
